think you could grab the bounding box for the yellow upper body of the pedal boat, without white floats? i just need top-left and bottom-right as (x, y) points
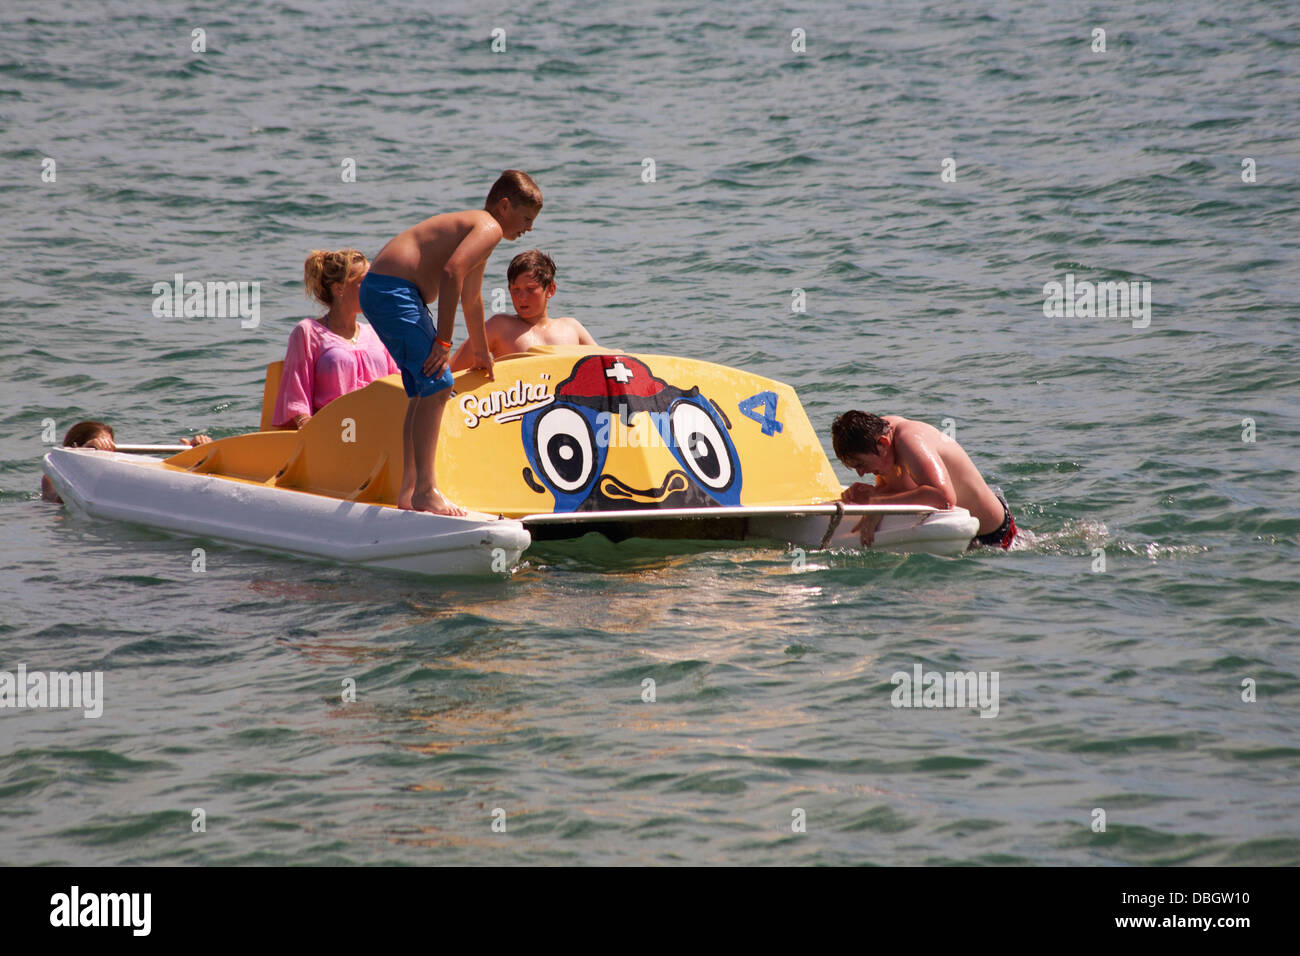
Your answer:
(168, 347), (840, 518)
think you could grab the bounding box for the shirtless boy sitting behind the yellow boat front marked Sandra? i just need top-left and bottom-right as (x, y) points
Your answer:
(451, 248), (595, 372)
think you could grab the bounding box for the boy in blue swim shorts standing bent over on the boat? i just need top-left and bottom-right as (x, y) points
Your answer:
(360, 169), (542, 515)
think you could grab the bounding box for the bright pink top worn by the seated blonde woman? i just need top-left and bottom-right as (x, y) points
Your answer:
(272, 319), (402, 427)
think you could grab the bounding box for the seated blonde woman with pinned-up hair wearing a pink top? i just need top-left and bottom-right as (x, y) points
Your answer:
(272, 248), (400, 428)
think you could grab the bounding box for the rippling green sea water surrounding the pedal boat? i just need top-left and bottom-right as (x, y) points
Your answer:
(0, 0), (1300, 865)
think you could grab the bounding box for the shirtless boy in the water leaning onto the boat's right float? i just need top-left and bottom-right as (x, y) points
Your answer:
(831, 411), (1015, 548)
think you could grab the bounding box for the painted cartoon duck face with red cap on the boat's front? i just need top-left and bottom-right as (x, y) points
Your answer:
(520, 355), (741, 511)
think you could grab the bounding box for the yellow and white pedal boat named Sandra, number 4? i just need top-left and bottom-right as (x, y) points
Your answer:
(43, 347), (978, 574)
